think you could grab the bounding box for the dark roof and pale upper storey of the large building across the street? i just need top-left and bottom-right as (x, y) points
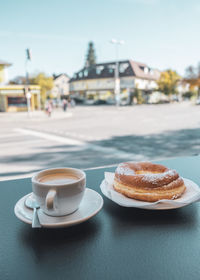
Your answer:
(69, 60), (160, 98)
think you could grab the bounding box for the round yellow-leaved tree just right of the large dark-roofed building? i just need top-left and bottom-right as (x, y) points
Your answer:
(157, 69), (180, 96)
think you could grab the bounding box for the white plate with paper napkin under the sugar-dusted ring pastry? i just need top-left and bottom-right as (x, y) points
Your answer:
(100, 172), (200, 210)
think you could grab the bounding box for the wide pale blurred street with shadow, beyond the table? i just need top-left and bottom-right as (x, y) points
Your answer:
(0, 103), (200, 180)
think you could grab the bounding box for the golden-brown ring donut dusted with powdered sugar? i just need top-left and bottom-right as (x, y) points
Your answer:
(113, 162), (186, 202)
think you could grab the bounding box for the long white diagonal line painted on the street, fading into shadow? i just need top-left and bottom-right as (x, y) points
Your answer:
(15, 128), (147, 161)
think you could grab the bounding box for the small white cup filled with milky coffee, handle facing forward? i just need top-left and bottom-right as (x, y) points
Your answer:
(32, 168), (86, 216)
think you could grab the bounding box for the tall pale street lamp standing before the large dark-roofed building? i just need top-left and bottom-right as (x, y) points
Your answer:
(110, 39), (124, 106)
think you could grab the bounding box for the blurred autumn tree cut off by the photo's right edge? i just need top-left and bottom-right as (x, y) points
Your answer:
(184, 63), (200, 96)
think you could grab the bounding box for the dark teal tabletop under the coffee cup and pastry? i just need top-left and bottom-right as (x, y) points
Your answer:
(0, 156), (200, 280)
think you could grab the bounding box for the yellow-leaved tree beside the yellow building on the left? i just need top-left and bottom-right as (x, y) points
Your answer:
(30, 73), (53, 106)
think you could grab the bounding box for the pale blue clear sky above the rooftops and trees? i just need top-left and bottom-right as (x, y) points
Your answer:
(0, 0), (200, 79)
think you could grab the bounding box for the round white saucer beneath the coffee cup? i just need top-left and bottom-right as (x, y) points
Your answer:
(14, 188), (103, 228)
